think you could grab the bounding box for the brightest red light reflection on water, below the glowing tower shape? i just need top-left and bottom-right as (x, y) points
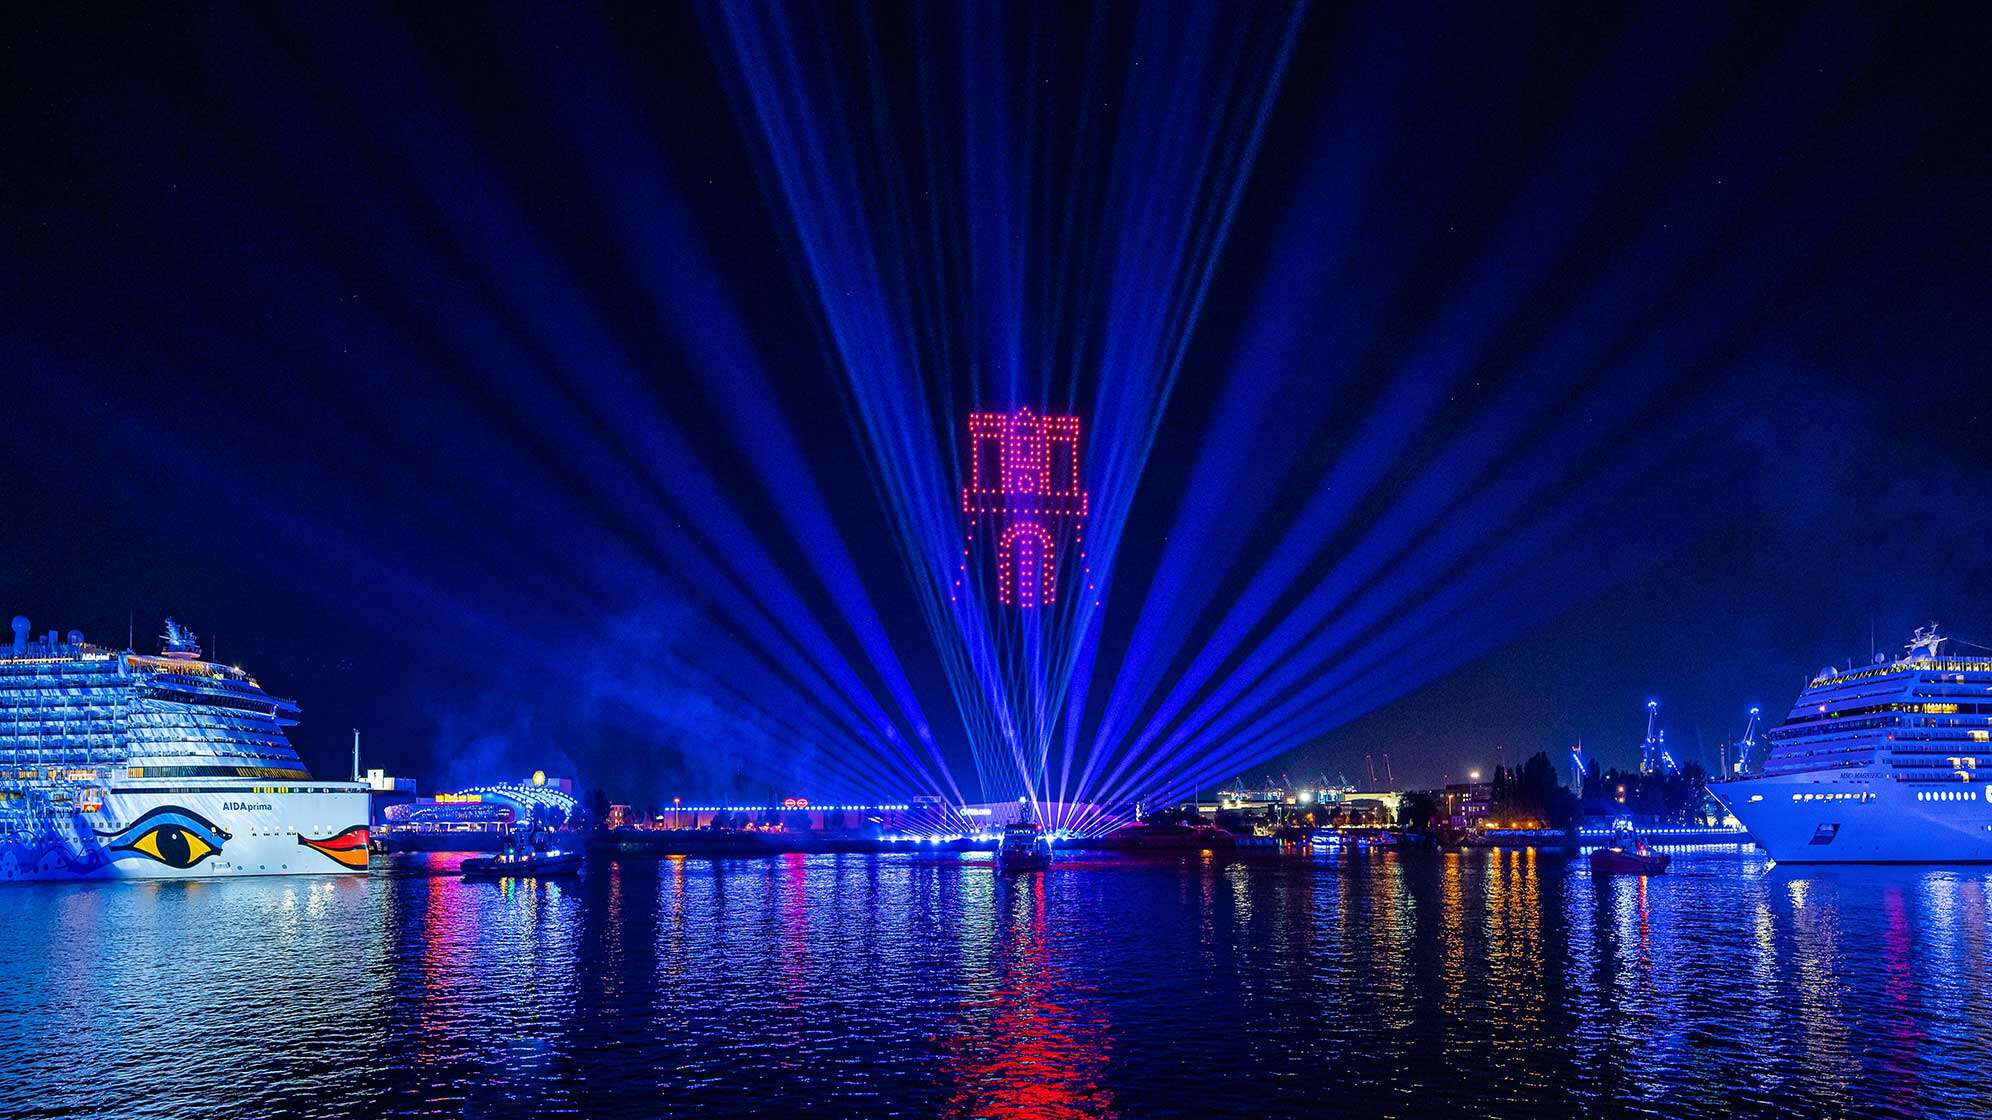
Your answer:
(944, 871), (1116, 1120)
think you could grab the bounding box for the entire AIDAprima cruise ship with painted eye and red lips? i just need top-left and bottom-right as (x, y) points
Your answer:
(0, 618), (367, 883)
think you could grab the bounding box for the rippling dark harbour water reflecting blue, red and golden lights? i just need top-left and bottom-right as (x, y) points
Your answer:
(0, 851), (1992, 1118)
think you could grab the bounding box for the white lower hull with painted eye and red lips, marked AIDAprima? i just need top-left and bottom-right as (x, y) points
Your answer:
(0, 781), (367, 883)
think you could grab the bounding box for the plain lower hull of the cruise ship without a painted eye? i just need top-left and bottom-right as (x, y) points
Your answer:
(1709, 771), (1992, 863)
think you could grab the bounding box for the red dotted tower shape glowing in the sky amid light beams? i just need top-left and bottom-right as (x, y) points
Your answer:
(956, 409), (1088, 610)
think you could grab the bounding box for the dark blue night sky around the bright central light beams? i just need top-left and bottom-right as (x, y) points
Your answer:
(0, 6), (1992, 797)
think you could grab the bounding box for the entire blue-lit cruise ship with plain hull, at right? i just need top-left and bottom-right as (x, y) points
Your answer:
(1711, 622), (1992, 863)
